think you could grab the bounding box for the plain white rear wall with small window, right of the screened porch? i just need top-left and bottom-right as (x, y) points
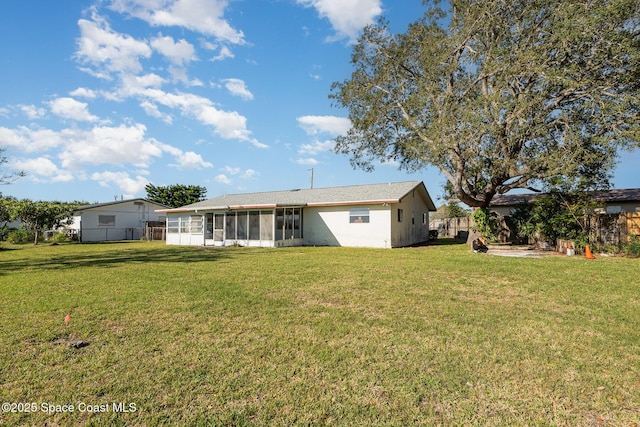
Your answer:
(303, 205), (391, 248)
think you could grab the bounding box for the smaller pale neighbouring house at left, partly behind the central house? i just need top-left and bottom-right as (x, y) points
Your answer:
(68, 199), (167, 242)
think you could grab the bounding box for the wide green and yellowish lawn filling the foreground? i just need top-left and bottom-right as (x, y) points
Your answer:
(0, 242), (640, 427)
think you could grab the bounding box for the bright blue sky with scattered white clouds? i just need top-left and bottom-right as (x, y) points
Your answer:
(0, 0), (640, 204)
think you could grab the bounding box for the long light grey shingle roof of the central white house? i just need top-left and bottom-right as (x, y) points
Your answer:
(159, 181), (436, 212)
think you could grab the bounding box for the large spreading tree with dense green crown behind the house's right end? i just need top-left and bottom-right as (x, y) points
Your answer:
(330, 0), (640, 207)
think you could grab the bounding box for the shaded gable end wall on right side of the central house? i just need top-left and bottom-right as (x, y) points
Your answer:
(391, 190), (429, 248)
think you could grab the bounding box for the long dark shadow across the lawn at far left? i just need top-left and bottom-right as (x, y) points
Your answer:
(0, 242), (235, 276)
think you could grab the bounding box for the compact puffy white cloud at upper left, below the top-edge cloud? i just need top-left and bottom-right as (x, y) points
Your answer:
(76, 14), (152, 79)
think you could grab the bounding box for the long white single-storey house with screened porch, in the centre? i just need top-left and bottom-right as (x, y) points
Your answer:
(157, 181), (436, 248)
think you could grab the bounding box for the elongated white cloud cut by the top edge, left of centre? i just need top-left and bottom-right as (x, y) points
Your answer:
(111, 0), (244, 44)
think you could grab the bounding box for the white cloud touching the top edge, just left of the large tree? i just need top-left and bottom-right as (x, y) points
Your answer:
(296, 0), (382, 42)
